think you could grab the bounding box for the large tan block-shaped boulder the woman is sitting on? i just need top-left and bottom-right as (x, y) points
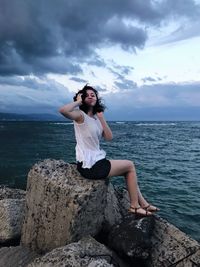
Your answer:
(21, 159), (107, 252)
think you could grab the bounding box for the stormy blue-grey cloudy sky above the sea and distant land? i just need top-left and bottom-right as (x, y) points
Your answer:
(0, 0), (200, 120)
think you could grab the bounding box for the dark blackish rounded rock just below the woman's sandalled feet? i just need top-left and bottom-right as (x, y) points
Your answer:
(108, 214), (154, 260)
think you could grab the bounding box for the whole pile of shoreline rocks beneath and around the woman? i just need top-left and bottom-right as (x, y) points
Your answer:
(0, 159), (200, 267)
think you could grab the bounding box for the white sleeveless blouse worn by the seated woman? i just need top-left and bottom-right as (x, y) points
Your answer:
(74, 111), (106, 168)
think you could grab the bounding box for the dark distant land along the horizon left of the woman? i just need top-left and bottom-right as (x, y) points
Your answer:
(0, 113), (66, 121)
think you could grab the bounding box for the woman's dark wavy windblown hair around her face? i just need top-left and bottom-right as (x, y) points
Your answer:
(73, 84), (106, 115)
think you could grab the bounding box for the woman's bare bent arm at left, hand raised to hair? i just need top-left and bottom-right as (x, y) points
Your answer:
(59, 96), (83, 123)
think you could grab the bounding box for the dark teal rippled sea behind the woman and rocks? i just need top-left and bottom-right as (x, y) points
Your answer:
(0, 121), (200, 242)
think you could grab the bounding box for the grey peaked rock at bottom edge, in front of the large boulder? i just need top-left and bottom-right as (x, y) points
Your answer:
(28, 237), (116, 267)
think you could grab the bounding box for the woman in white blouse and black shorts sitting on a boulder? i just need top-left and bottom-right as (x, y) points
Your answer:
(59, 85), (158, 216)
